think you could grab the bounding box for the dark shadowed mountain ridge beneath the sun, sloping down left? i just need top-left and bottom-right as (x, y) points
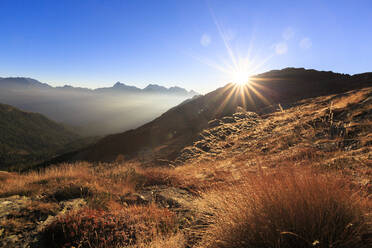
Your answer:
(75, 68), (372, 163)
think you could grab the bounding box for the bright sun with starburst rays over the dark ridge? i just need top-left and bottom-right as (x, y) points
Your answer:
(193, 6), (274, 114)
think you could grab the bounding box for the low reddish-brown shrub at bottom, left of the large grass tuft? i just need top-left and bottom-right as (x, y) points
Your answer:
(44, 205), (176, 247)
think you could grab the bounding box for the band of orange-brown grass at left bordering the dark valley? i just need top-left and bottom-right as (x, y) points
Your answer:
(0, 162), (203, 210)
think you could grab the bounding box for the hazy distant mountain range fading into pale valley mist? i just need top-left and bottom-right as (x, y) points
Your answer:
(0, 77), (197, 136)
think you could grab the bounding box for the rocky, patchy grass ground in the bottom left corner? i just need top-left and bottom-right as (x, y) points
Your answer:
(0, 195), (86, 248)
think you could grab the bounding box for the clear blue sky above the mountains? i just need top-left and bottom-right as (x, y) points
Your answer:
(0, 0), (372, 93)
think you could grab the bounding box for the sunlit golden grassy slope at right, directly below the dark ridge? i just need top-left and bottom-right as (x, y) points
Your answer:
(174, 87), (372, 169)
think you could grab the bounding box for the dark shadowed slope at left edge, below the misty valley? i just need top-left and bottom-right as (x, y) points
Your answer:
(0, 104), (80, 170)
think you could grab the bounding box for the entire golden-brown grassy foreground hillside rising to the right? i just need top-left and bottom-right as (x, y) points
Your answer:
(0, 87), (372, 248)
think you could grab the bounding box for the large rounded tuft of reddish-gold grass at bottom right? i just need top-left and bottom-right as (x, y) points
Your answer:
(196, 168), (372, 248)
